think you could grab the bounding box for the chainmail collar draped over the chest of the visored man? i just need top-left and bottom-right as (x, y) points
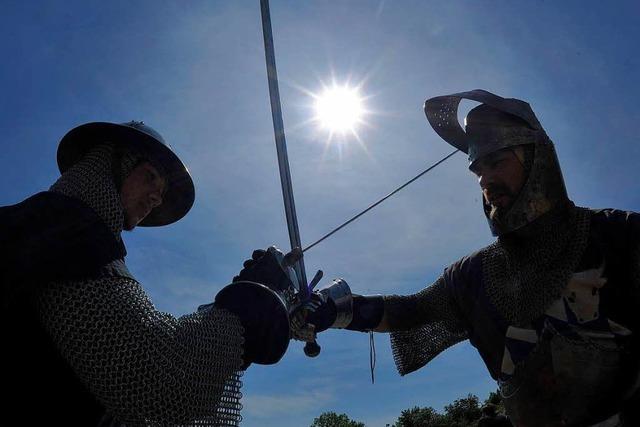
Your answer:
(482, 205), (591, 327)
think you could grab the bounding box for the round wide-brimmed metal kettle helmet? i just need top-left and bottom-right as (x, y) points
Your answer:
(57, 121), (195, 227)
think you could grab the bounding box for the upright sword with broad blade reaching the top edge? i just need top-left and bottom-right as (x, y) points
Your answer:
(260, 0), (322, 357)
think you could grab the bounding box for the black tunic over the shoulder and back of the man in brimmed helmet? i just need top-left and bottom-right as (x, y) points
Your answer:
(0, 192), (130, 426)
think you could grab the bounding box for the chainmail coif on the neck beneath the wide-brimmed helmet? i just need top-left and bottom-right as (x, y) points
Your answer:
(49, 144), (125, 240)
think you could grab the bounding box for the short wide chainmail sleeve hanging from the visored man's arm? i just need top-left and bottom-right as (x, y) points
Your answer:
(385, 277), (468, 375)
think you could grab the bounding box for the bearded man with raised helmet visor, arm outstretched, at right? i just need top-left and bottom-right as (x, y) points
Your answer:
(242, 90), (640, 426)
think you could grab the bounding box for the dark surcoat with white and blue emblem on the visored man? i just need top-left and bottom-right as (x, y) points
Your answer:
(444, 209), (640, 425)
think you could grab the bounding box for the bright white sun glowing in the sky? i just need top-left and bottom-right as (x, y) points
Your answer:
(314, 85), (365, 134)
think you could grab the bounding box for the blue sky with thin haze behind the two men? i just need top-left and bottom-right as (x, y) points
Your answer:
(0, 0), (640, 427)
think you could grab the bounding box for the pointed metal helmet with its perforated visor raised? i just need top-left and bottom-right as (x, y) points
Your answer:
(424, 89), (569, 236)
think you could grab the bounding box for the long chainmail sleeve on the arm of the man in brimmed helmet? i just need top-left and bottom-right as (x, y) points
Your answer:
(38, 277), (243, 427)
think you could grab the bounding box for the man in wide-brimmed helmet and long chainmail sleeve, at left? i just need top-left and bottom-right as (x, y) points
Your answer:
(0, 121), (293, 427)
